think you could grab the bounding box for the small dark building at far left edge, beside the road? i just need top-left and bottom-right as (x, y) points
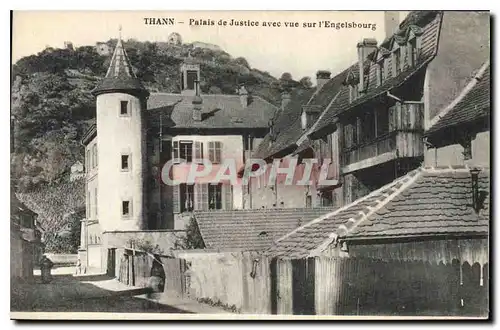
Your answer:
(10, 192), (43, 282)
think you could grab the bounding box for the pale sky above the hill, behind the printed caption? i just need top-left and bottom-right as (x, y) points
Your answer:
(12, 11), (408, 81)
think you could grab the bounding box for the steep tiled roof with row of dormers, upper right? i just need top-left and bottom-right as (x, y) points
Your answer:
(310, 12), (441, 138)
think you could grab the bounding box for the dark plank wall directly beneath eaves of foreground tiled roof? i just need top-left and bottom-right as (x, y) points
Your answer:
(292, 257), (488, 316)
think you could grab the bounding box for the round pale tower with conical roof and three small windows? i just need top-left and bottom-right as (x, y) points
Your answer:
(92, 38), (149, 232)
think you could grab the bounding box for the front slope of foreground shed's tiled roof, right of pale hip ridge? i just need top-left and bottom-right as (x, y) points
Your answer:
(346, 169), (490, 239)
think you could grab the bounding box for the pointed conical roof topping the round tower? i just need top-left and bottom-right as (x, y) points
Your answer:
(92, 38), (149, 96)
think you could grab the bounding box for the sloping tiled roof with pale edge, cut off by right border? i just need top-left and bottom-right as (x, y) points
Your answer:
(425, 61), (491, 136)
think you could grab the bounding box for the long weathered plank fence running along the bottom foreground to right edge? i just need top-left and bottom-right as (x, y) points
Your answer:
(112, 251), (489, 316)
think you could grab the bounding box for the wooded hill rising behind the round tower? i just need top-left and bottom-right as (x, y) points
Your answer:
(11, 39), (311, 250)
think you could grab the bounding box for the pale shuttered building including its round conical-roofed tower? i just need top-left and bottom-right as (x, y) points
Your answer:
(79, 36), (277, 270)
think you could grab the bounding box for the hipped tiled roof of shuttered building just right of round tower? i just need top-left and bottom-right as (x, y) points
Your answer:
(147, 93), (277, 128)
